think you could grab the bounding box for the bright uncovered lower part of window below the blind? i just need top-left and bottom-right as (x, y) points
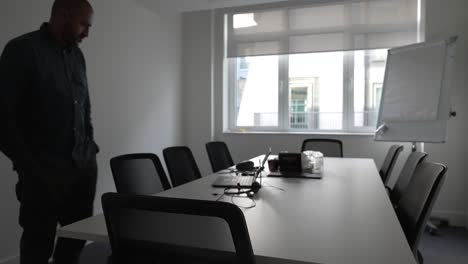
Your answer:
(229, 50), (387, 132)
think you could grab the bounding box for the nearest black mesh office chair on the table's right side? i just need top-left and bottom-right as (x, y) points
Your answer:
(396, 162), (447, 264)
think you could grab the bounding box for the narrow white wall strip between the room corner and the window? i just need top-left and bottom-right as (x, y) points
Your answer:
(182, 11), (213, 175)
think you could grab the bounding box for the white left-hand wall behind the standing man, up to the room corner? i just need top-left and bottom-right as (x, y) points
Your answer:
(0, 0), (182, 263)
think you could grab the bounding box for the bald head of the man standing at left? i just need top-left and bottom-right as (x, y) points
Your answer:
(49, 0), (93, 45)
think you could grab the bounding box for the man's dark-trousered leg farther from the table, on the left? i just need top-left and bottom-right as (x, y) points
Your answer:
(17, 175), (58, 264)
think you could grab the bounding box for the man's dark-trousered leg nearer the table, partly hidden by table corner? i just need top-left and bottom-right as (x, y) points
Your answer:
(54, 163), (97, 264)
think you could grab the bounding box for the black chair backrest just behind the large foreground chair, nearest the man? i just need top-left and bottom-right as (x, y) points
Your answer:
(110, 153), (171, 194)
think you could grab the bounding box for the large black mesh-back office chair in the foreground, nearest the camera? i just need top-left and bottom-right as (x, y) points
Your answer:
(102, 193), (255, 264)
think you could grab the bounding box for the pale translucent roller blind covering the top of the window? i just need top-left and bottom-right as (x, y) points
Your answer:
(226, 0), (419, 57)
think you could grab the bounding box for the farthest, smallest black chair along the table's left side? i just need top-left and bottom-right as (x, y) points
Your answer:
(205, 141), (234, 172)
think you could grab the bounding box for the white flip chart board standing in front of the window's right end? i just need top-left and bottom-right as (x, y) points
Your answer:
(375, 37), (456, 143)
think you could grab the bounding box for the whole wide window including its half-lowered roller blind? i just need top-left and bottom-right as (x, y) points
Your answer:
(225, 0), (419, 133)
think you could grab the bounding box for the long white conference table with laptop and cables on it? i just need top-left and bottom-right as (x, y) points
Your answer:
(58, 157), (416, 264)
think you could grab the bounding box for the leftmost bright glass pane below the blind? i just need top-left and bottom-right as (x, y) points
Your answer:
(235, 56), (279, 127)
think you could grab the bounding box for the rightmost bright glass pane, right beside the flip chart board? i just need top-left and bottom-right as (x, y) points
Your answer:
(354, 49), (387, 127)
